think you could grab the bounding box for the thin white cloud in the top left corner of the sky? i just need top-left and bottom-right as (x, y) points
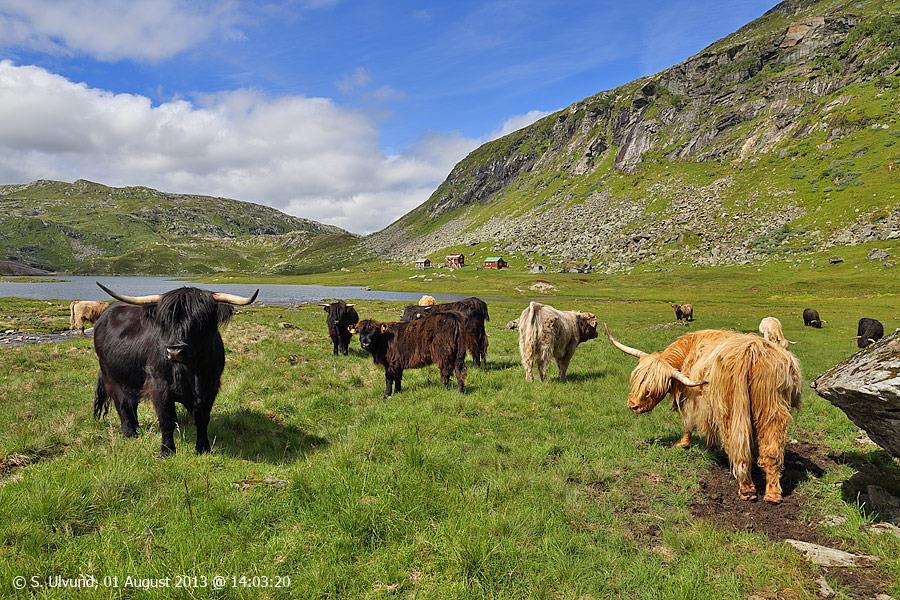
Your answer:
(0, 0), (243, 61)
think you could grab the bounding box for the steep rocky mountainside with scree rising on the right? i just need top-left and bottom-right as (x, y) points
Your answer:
(364, 0), (900, 271)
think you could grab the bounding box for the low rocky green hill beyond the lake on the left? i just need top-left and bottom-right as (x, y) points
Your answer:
(0, 180), (357, 275)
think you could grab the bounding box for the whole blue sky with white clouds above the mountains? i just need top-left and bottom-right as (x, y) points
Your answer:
(0, 0), (774, 232)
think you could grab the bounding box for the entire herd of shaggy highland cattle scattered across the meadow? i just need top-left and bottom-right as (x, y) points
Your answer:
(71, 284), (884, 503)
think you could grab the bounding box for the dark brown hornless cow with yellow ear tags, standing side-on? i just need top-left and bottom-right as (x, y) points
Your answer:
(353, 313), (466, 398)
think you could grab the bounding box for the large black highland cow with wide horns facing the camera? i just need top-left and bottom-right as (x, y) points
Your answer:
(94, 283), (259, 456)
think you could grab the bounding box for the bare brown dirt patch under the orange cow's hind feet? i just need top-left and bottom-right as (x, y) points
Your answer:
(691, 441), (890, 598)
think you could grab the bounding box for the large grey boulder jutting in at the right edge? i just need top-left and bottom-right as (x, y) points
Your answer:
(811, 329), (900, 457)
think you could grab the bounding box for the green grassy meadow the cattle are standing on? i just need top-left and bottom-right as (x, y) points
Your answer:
(0, 256), (900, 599)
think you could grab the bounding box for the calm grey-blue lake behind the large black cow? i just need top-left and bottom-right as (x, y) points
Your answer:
(0, 275), (464, 304)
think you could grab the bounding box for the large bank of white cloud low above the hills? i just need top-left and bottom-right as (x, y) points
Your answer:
(0, 61), (543, 233)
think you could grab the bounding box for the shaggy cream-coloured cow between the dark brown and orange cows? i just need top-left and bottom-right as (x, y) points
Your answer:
(519, 302), (597, 381)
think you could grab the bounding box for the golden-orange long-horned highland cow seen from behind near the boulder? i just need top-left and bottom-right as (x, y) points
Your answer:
(606, 328), (800, 503)
